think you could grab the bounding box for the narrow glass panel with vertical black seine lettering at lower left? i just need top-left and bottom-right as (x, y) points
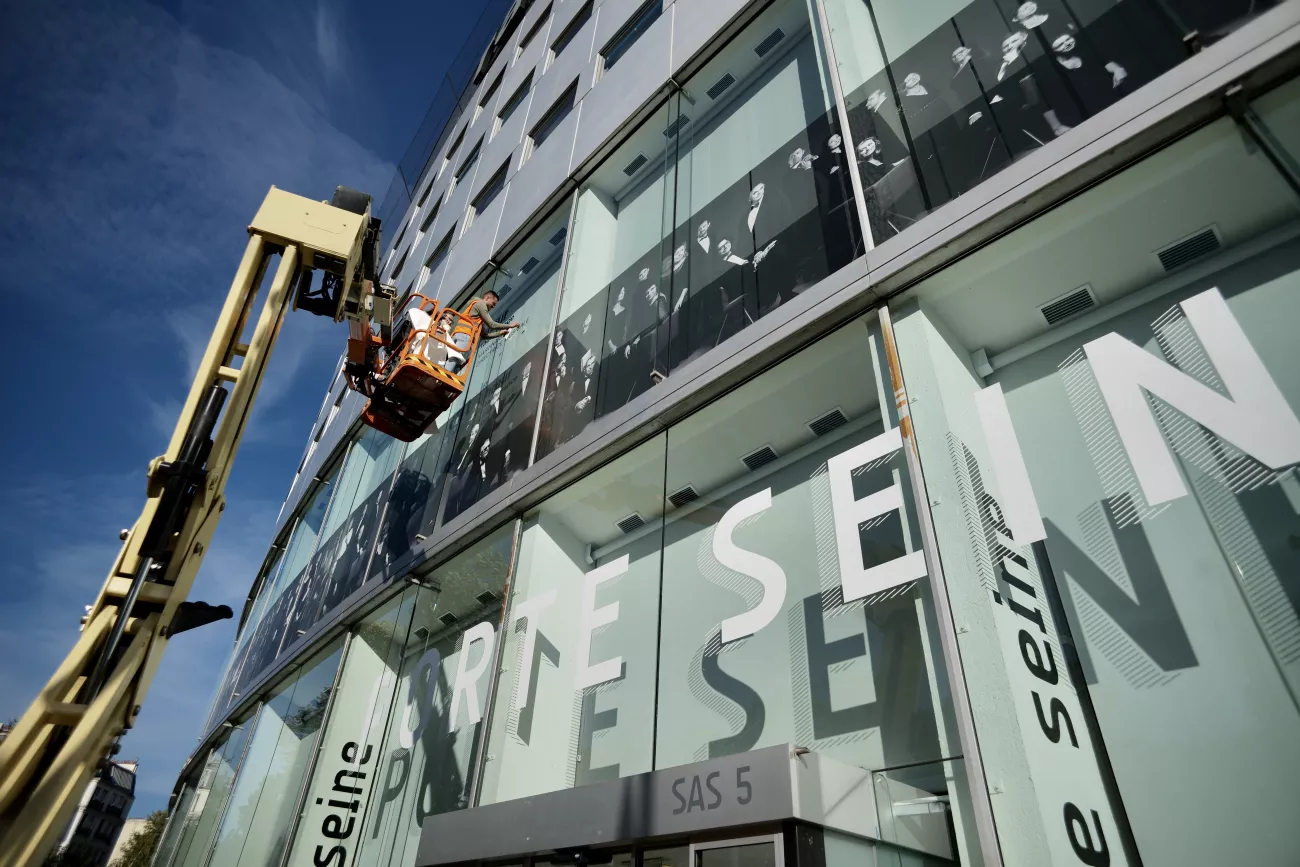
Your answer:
(289, 588), (416, 867)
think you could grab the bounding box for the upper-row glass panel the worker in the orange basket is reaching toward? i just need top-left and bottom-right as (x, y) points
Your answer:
(443, 203), (568, 521)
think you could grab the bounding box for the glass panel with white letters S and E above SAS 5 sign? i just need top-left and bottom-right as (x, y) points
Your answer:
(655, 316), (971, 862)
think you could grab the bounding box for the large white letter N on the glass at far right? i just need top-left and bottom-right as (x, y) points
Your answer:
(1083, 289), (1300, 506)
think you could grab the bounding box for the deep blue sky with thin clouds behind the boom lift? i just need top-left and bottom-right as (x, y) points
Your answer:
(0, 0), (481, 815)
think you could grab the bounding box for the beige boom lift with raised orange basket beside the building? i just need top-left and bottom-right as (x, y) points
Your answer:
(0, 187), (478, 867)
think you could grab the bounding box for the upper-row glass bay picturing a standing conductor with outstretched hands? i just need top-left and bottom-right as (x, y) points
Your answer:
(537, 1), (862, 458)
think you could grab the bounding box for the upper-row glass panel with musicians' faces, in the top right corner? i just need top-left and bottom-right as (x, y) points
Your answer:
(826, 0), (1277, 243)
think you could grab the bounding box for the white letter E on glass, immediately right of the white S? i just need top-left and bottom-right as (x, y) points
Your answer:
(826, 428), (926, 602)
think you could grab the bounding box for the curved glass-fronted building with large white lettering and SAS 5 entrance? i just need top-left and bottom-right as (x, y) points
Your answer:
(155, 0), (1300, 867)
